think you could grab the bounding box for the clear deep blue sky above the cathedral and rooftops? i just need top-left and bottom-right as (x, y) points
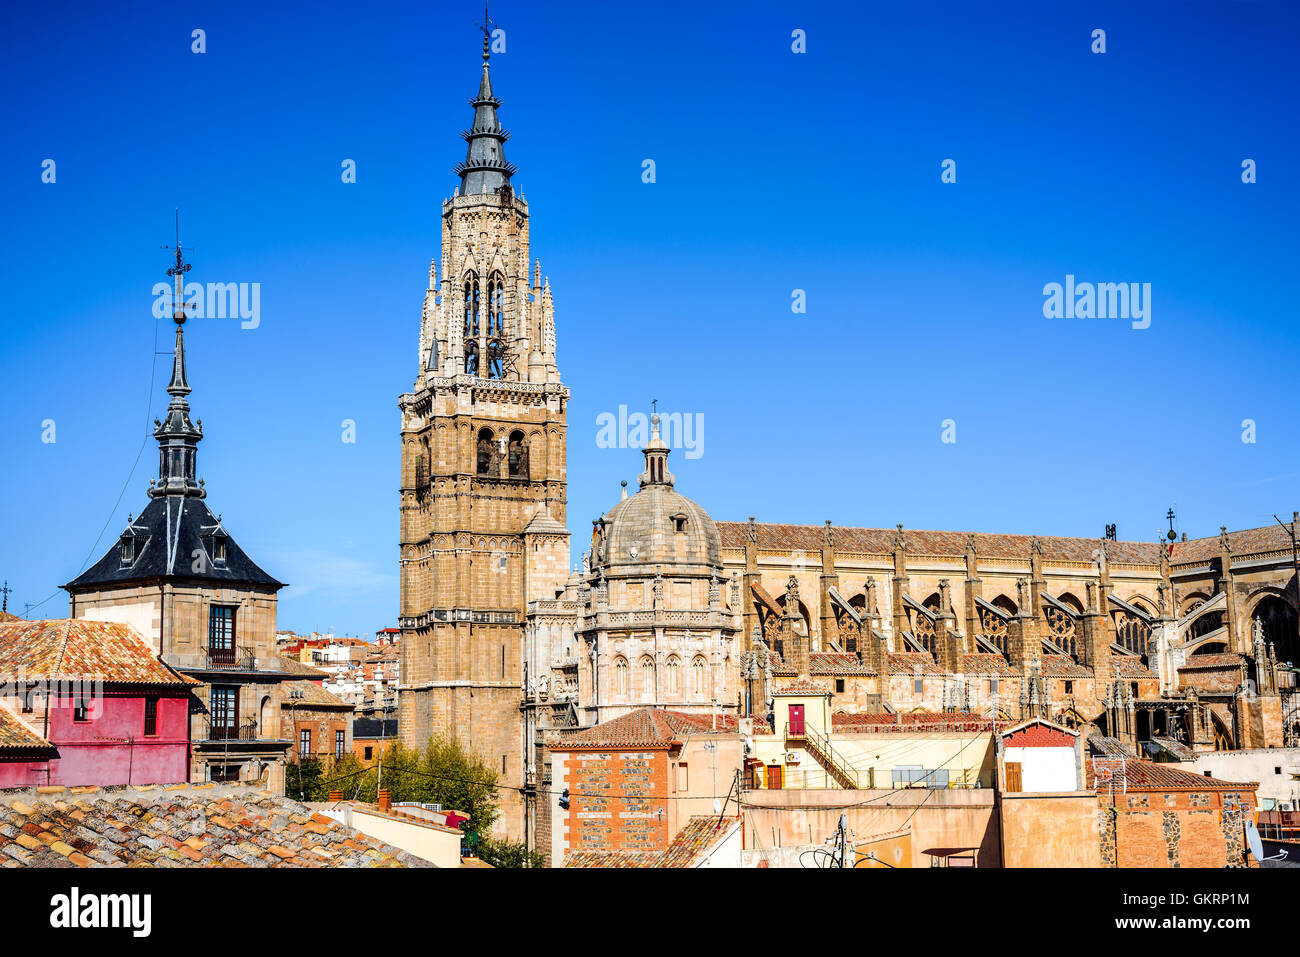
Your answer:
(0, 0), (1300, 635)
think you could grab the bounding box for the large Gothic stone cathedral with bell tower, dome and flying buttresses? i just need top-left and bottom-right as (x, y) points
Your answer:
(399, 31), (1300, 848)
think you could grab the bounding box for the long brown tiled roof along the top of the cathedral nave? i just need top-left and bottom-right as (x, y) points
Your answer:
(716, 521), (1291, 564)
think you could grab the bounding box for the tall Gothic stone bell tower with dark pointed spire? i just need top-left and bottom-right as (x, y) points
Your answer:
(399, 25), (568, 837)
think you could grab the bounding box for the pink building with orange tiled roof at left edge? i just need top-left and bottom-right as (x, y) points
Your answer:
(0, 619), (196, 788)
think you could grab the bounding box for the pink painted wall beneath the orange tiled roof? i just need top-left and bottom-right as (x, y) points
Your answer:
(0, 692), (190, 787)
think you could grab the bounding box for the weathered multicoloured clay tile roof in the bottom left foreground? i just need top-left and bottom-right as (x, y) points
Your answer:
(0, 784), (432, 867)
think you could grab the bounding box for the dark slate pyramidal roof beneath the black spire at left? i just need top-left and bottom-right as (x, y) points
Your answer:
(64, 495), (283, 592)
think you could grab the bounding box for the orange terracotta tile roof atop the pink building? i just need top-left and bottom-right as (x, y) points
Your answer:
(0, 618), (199, 685)
